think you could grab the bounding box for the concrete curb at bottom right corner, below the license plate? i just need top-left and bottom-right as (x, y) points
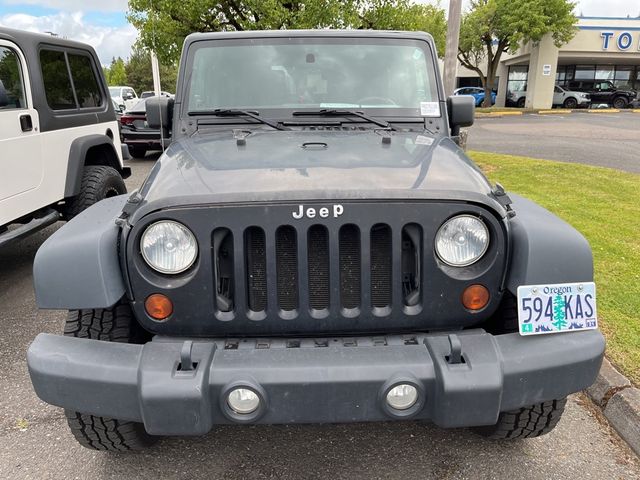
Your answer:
(586, 358), (640, 455)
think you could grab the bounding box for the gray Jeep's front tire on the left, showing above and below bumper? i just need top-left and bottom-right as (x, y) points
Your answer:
(64, 302), (158, 452)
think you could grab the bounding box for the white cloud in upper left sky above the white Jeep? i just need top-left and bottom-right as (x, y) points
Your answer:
(0, 11), (138, 65)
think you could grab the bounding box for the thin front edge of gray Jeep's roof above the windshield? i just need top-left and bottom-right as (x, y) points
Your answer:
(184, 29), (433, 46)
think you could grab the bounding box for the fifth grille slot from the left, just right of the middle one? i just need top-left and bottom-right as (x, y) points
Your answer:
(339, 225), (361, 308)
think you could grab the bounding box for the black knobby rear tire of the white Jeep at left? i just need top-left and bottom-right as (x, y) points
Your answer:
(63, 165), (127, 220)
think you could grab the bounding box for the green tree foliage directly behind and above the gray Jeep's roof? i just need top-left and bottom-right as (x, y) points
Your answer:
(128, 0), (446, 63)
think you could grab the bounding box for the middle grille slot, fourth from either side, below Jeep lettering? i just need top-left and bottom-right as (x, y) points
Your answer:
(307, 225), (329, 310)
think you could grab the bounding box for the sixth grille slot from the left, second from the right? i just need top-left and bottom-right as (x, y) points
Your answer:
(371, 224), (392, 308)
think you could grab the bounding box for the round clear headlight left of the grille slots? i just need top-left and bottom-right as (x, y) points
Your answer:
(140, 220), (198, 274)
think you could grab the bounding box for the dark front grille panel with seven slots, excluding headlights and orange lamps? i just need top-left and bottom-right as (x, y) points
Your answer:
(127, 200), (507, 337)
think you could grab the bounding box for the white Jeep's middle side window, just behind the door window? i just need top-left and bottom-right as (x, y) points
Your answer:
(40, 50), (76, 110)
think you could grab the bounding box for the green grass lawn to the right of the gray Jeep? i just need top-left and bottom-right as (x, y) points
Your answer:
(470, 152), (640, 385)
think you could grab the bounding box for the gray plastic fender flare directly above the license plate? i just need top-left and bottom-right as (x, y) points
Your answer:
(506, 193), (593, 295)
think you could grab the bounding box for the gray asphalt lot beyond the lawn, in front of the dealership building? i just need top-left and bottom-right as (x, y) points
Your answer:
(468, 111), (640, 173)
